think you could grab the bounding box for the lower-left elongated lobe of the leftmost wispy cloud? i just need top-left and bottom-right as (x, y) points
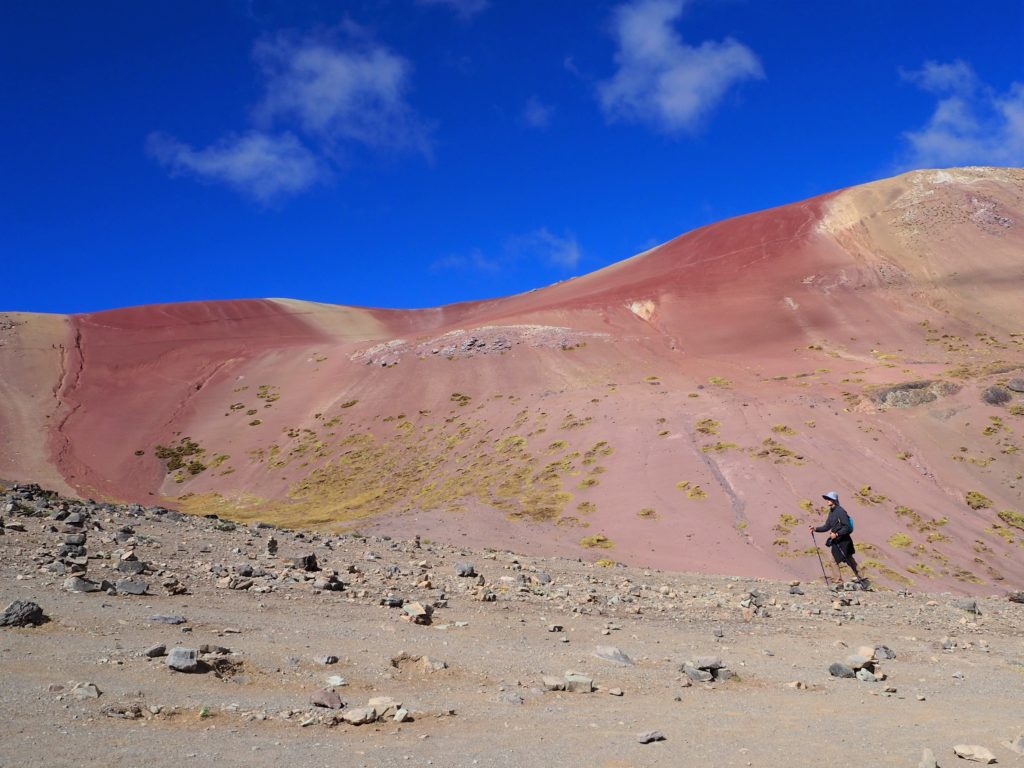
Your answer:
(146, 132), (324, 203)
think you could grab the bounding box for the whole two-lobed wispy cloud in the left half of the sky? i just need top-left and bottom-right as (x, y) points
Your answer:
(146, 30), (430, 203)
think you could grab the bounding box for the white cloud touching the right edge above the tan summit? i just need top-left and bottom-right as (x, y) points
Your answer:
(900, 59), (1024, 168)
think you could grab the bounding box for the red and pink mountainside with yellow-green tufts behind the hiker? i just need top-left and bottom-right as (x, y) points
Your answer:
(0, 168), (1024, 592)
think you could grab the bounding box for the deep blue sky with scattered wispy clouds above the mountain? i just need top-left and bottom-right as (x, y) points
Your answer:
(0, 0), (1024, 312)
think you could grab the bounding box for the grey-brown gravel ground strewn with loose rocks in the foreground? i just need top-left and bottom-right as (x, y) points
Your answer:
(0, 486), (1024, 768)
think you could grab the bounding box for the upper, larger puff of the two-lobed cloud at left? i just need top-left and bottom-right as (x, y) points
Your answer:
(255, 36), (429, 153)
